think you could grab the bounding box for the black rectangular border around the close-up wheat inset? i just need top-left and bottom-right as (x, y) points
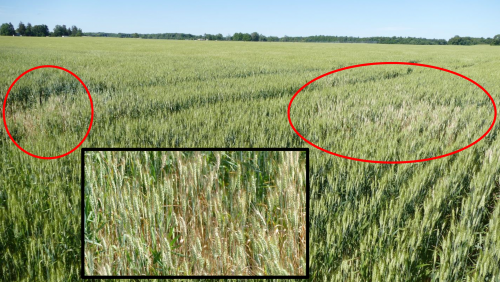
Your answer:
(80, 148), (310, 279)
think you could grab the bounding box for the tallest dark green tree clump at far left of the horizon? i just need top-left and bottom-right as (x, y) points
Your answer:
(0, 22), (83, 37)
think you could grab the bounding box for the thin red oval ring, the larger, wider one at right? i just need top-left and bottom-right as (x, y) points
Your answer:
(288, 62), (497, 164)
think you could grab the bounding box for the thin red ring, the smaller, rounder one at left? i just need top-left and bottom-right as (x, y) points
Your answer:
(2, 65), (94, 160)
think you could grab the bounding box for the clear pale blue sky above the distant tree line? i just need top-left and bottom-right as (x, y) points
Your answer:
(0, 0), (500, 39)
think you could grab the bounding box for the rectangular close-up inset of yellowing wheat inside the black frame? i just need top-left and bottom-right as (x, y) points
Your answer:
(84, 151), (307, 276)
